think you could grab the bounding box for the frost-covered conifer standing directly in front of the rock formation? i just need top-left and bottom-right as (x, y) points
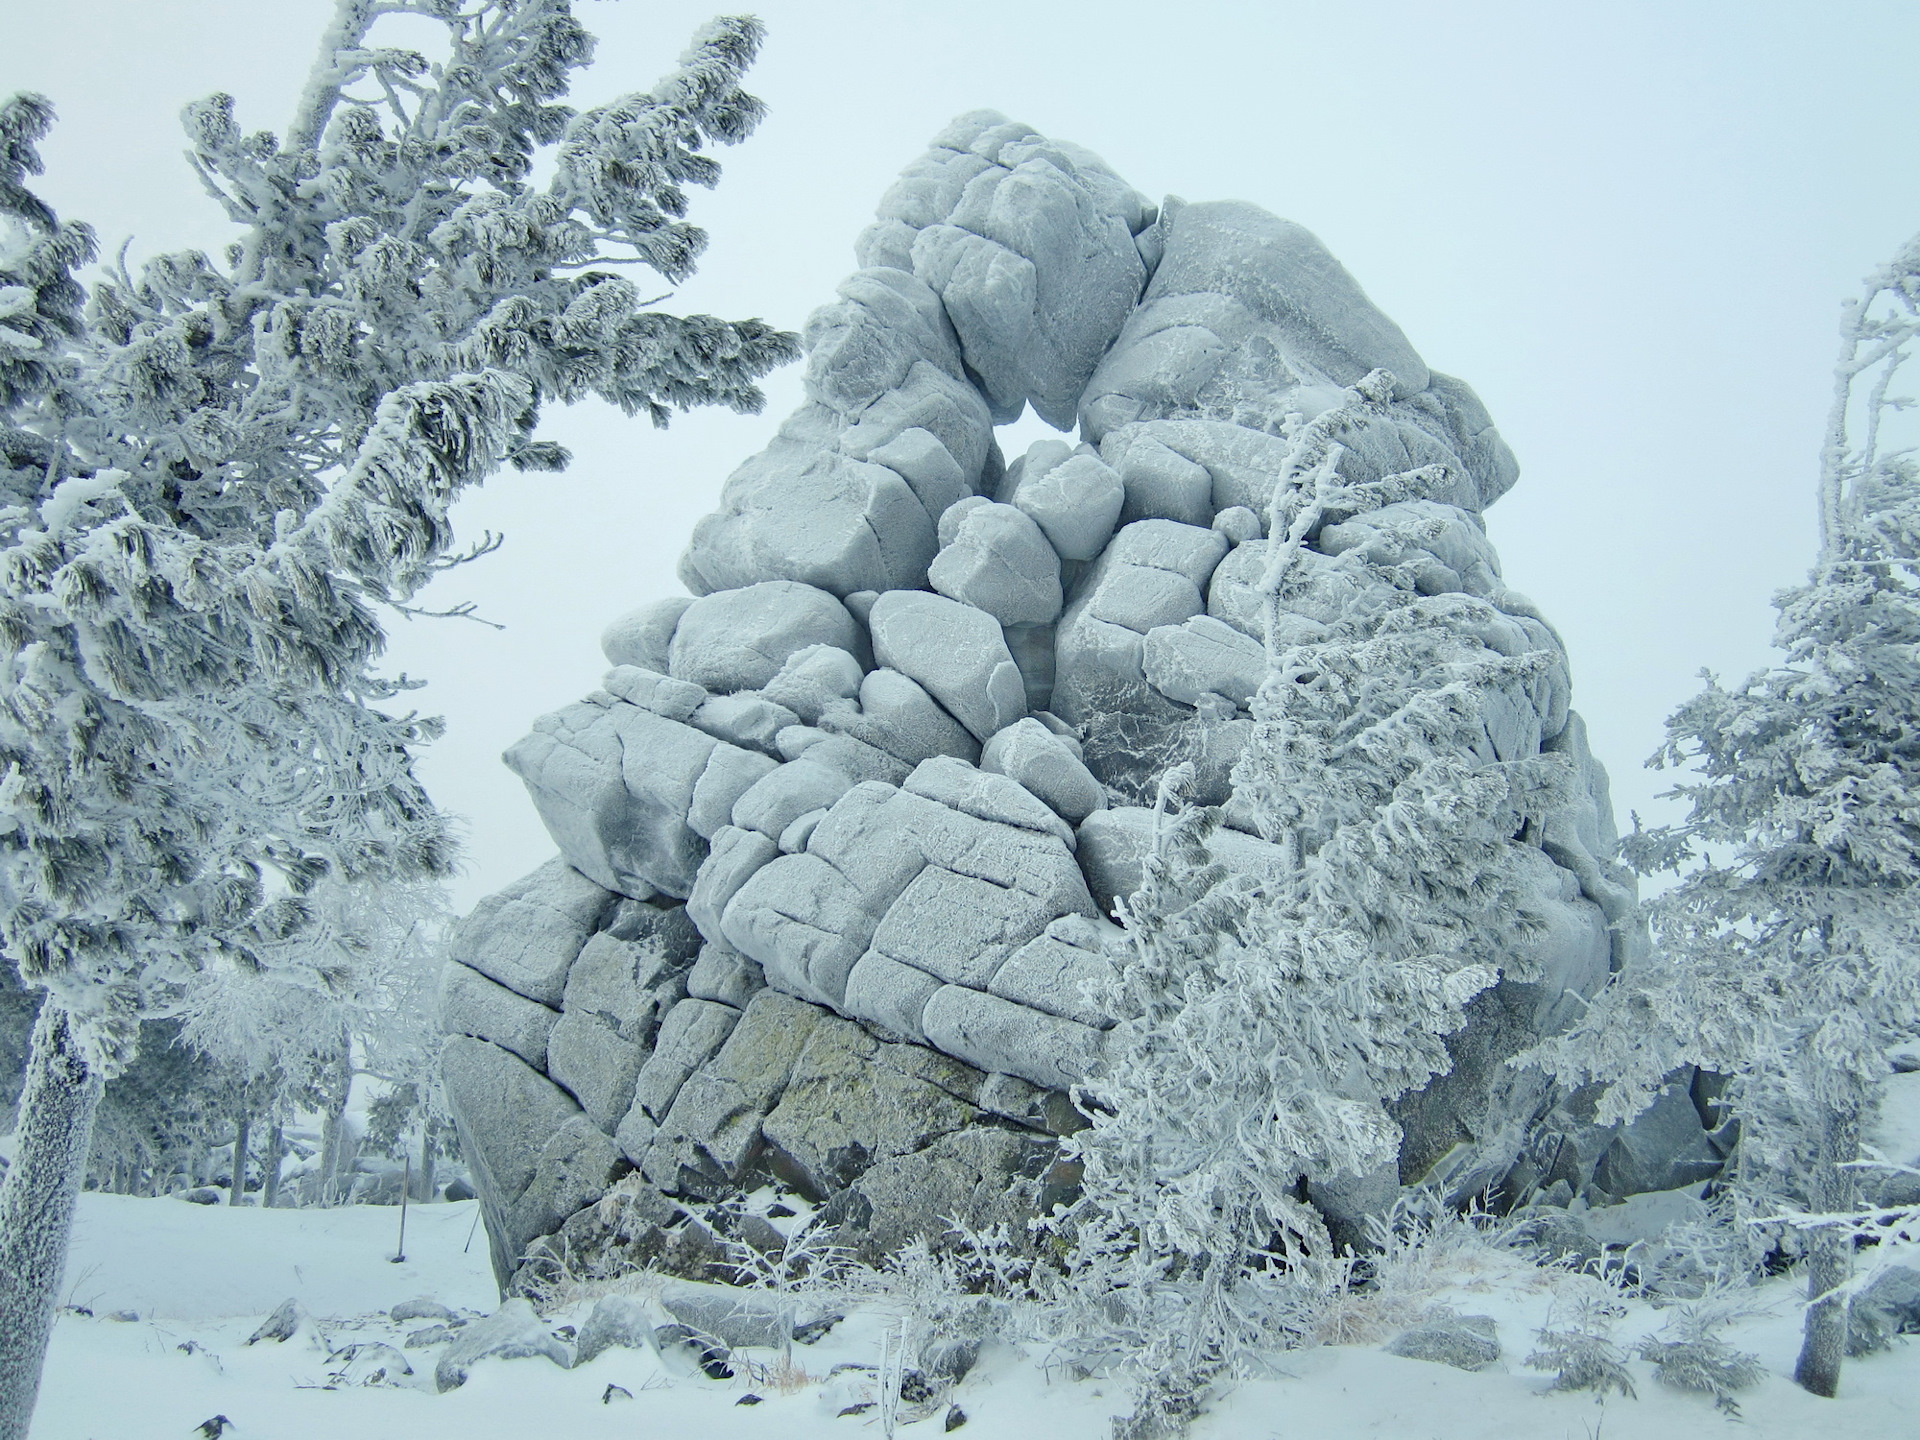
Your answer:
(1068, 372), (1571, 1436)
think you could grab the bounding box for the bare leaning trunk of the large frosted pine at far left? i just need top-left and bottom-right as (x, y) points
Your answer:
(0, 996), (104, 1440)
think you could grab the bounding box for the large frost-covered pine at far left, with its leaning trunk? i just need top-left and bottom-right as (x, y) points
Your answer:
(0, 0), (797, 1440)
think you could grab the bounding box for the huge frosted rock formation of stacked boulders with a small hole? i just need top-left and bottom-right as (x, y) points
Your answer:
(444, 111), (1718, 1284)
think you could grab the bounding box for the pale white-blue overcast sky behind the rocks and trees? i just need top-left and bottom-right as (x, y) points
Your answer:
(0, 0), (1920, 904)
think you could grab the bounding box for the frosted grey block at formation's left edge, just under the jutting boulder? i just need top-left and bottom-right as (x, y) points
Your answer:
(449, 858), (618, 1006)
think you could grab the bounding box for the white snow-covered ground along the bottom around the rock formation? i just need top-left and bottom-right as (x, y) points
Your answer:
(33, 1194), (1920, 1440)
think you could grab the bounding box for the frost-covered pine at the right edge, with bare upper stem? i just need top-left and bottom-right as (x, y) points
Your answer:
(1544, 236), (1920, 1396)
